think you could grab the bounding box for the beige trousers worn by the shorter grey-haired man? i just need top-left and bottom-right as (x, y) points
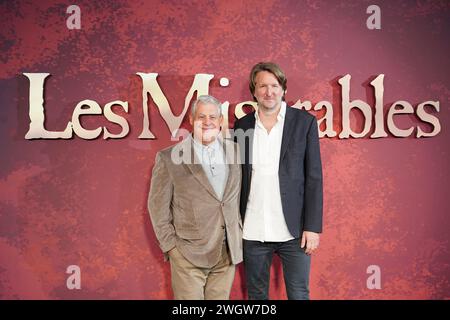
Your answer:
(169, 243), (236, 300)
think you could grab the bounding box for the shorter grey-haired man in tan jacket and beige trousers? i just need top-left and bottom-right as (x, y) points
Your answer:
(148, 96), (242, 300)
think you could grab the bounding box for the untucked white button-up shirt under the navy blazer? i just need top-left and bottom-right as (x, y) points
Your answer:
(243, 101), (294, 242)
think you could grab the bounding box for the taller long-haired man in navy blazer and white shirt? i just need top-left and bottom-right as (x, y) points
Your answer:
(234, 62), (323, 300)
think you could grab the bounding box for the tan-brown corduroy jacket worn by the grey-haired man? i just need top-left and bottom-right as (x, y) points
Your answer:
(148, 137), (242, 268)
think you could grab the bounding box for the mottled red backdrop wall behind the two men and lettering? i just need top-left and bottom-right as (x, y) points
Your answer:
(0, 0), (450, 299)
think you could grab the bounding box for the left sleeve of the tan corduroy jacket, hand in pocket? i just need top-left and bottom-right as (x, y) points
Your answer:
(148, 152), (176, 253)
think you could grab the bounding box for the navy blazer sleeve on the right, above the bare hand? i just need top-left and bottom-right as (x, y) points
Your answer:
(303, 117), (323, 233)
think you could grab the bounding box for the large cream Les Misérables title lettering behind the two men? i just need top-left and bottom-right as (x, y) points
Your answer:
(23, 72), (441, 140)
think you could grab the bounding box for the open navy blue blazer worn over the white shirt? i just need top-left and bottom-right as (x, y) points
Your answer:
(234, 107), (323, 238)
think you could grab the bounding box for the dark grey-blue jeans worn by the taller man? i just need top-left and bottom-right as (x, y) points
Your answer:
(244, 239), (311, 300)
